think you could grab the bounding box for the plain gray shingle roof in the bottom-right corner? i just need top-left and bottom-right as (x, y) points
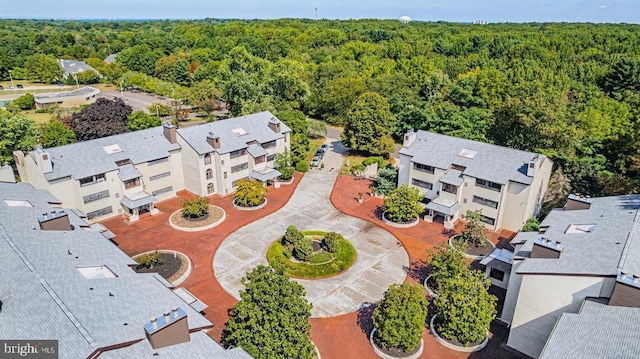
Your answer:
(540, 300), (640, 359)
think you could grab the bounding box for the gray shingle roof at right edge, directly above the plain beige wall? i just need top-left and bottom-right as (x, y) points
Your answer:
(516, 195), (640, 276)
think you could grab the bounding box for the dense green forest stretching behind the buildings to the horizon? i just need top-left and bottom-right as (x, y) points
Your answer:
(0, 19), (640, 200)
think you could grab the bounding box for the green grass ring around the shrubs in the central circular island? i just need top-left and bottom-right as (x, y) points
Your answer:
(267, 231), (356, 279)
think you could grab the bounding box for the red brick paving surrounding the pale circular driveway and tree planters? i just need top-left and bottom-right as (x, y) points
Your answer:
(103, 173), (517, 359)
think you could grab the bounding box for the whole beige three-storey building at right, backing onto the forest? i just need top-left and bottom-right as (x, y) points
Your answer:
(398, 131), (553, 231)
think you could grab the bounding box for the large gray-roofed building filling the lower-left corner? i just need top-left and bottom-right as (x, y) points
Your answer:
(0, 183), (251, 359)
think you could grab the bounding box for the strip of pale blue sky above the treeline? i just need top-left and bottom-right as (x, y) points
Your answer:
(0, 0), (640, 23)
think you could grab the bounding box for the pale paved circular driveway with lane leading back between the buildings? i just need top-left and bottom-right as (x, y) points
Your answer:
(213, 141), (409, 318)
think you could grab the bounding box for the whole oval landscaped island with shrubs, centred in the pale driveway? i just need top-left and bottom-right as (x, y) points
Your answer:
(267, 226), (356, 279)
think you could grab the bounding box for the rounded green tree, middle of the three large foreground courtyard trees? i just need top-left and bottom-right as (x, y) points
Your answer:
(372, 282), (429, 352)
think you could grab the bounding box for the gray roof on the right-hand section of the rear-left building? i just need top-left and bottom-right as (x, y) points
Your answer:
(177, 111), (291, 155)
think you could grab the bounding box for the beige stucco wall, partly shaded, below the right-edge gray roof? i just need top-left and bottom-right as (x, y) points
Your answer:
(507, 274), (614, 358)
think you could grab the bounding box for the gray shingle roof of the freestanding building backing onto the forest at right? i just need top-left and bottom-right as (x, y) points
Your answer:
(400, 131), (549, 185)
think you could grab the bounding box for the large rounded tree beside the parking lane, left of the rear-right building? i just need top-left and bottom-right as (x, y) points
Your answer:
(342, 92), (396, 156)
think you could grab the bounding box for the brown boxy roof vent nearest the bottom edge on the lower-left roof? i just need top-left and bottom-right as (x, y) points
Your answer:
(144, 307), (189, 349)
